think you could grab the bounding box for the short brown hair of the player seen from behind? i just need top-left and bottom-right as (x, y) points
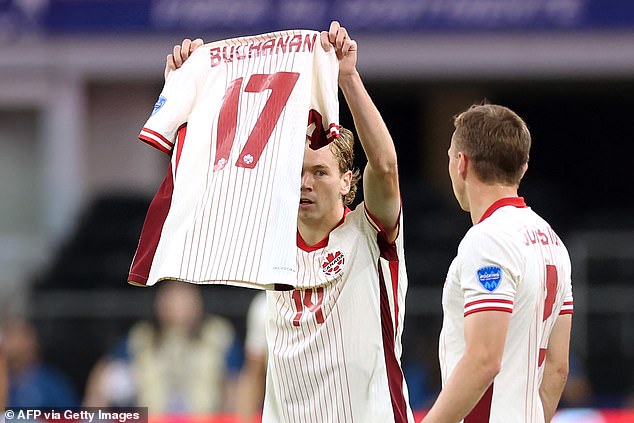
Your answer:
(454, 104), (531, 185)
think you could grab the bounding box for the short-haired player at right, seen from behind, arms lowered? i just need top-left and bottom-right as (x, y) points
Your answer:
(423, 104), (573, 423)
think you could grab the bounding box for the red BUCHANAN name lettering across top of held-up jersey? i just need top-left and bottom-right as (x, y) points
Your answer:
(209, 33), (317, 68)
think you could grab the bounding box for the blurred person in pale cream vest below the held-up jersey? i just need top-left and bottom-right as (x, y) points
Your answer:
(84, 282), (241, 414)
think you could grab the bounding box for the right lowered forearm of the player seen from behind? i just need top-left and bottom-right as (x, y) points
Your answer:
(539, 314), (572, 422)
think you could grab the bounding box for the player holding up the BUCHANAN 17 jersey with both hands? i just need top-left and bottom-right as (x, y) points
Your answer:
(167, 22), (414, 423)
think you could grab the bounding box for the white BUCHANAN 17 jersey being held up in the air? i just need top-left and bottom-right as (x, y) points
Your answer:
(128, 30), (339, 288)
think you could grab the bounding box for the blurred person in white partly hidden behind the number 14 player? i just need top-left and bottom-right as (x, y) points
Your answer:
(236, 292), (267, 423)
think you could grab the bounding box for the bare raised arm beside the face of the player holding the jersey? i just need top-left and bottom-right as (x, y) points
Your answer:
(321, 21), (401, 241)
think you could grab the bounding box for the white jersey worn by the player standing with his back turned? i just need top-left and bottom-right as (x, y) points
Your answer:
(439, 197), (573, 423)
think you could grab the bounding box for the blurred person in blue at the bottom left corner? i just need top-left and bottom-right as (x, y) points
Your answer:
(4, 319), (79, 407)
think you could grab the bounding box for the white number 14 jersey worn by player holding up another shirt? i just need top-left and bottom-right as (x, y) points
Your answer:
(262, 204), (414, 423)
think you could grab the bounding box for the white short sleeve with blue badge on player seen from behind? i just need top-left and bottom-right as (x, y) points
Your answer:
(458, 228), (521, 316)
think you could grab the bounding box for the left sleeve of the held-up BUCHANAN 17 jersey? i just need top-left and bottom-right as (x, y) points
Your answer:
(139, 52), (203, 154)
